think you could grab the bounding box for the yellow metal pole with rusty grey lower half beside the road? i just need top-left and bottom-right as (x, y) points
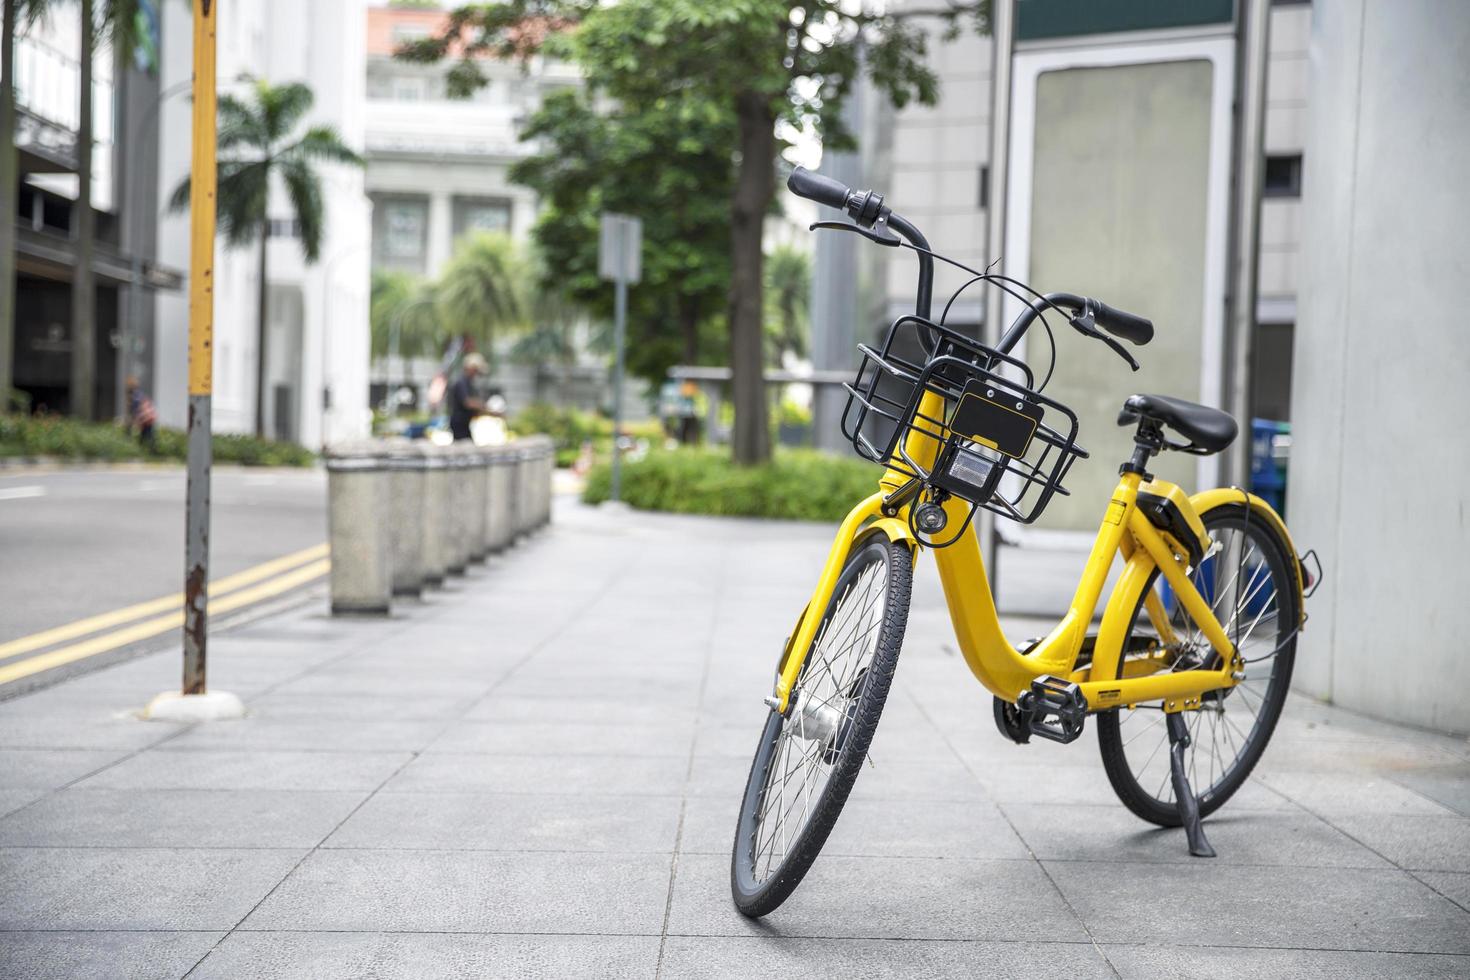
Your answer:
(182, 0), (218, 695)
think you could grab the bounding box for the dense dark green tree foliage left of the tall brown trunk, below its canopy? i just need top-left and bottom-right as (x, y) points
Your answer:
(510, 91), (735, 385)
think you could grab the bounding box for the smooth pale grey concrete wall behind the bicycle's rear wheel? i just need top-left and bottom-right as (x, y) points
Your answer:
(1288, 0), (1470, 732)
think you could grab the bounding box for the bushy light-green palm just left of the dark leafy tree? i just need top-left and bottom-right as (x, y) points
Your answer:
(440, 232), (529, 360)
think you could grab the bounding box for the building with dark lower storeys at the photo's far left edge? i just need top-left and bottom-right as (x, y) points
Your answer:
(12, 3), (171, 417)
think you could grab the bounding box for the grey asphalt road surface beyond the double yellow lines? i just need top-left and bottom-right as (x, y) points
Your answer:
(0, 466), (326, 644)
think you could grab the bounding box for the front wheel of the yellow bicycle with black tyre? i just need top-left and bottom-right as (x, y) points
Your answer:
(731, 533), (913, 918)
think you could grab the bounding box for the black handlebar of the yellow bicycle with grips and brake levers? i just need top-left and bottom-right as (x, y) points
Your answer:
(786, 166), (1154, 370)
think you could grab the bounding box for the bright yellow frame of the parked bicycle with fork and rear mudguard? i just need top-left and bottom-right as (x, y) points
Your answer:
(775, 392), (1301, 711)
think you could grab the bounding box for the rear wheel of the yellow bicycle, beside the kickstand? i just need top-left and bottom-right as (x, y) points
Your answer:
(1097, 504), (1301, 827)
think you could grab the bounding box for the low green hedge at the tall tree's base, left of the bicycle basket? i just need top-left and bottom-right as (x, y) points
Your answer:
(582, 450), (881, 522)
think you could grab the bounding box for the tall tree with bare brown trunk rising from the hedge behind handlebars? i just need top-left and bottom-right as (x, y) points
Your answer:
(403, 0), (989, 463)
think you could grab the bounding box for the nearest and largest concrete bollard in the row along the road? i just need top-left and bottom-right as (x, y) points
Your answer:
(326, 442), (392, 614)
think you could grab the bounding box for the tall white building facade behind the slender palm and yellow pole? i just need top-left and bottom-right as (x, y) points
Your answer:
(154, 0), (372, 447)
